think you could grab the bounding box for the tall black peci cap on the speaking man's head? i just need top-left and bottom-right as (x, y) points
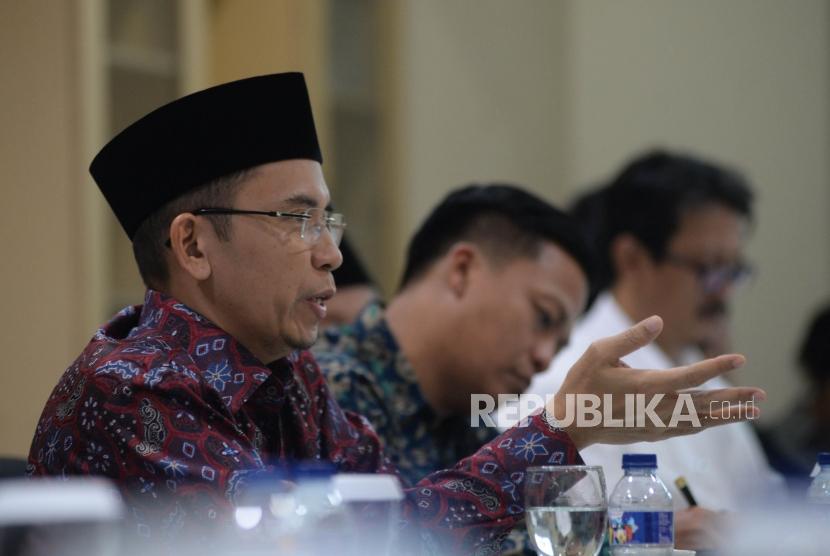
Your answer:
(89, 73), (323, 239)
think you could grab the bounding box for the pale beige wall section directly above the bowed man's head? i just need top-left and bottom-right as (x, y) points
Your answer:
(398, 0), (565, 249)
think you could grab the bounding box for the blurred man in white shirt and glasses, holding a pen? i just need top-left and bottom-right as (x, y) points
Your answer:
(508, 151), (779, 549)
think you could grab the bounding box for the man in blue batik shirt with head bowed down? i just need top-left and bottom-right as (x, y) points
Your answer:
(314, 185), (590, 552)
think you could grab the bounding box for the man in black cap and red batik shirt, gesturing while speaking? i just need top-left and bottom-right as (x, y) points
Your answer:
(28, 73), (761, 554)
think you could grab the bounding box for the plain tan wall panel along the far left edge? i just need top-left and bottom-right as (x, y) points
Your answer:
(0, 2), (83, 455)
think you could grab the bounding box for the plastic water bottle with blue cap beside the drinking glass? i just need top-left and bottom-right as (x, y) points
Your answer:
(608, 454), (674, 556)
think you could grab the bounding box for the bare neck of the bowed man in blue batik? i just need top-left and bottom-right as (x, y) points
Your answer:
(386, 285), (458, 415)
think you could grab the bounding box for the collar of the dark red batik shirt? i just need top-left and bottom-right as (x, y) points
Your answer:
(100, 289), (280, 415)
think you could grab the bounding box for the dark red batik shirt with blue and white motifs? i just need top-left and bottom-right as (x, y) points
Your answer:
(28, 290), (581, 552)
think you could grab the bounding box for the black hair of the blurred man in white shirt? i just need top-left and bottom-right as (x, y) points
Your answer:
(570, 150), (754, 293)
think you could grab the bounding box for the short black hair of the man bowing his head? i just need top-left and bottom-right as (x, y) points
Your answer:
(401, 183), (594, 288)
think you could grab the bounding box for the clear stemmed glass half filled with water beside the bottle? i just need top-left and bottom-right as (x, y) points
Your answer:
(525, 465), (608, 556)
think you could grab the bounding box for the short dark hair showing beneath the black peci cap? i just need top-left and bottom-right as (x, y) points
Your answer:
(133, 169), (254, 291)
